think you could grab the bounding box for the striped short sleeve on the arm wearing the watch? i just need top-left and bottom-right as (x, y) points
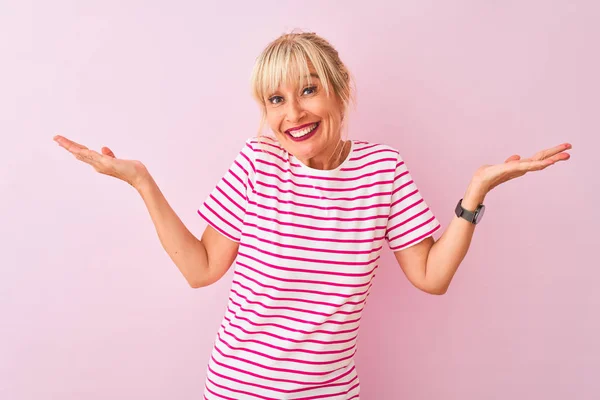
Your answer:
(385, 155), (441, 251)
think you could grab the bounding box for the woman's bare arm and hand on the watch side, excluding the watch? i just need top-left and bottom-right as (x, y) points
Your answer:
(414, 143), (572, 294)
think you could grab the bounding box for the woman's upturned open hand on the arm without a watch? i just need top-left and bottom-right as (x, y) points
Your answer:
(54, 135), (149, 189)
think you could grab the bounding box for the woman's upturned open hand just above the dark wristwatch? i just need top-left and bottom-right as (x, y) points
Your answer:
(473, 143), (572, 193)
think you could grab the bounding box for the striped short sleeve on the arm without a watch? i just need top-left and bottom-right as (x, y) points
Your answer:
(198, 139), (256, 243)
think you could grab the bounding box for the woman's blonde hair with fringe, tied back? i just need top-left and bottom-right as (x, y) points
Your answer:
(251, 32), (356, 160)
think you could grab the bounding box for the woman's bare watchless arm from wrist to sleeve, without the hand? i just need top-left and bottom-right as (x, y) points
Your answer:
(136, 174), (238, 288)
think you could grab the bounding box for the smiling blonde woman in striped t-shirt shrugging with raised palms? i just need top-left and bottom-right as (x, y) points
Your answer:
(55, 33), (570, 399)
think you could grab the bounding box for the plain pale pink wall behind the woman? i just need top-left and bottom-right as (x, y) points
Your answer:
(0, 0), (600, 400)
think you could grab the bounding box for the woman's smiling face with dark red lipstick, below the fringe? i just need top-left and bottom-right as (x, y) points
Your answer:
(265, 66), (342, 168)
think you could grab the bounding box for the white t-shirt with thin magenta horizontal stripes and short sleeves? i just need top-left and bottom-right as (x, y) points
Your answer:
(198, 138), (440, 400)
